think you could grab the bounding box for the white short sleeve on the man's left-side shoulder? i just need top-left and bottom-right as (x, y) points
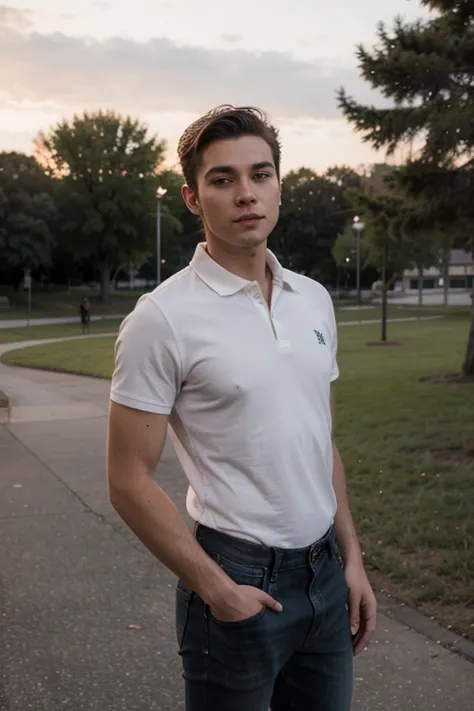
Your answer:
(110, 296), (181, 415)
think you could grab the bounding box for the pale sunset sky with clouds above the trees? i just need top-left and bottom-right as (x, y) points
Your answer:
(0, 0), (434, 172)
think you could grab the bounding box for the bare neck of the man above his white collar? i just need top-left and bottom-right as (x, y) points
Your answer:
(206, 237), (268, 286)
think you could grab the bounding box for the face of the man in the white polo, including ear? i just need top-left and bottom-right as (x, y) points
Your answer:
(183, 136), (280, 247)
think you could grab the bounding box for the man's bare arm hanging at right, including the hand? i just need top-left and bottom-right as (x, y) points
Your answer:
(331, 393), (377, 655)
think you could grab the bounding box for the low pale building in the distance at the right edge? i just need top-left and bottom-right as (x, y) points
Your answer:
(402, 249), (474, 291)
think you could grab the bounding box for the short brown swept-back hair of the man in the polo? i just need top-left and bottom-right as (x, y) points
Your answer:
(178, 104), (281, 191)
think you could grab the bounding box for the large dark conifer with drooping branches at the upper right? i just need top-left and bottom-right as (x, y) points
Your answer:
(339, 0), (474, 379)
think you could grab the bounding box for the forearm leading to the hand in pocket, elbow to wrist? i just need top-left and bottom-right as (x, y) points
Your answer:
(109, 475), (235, 606)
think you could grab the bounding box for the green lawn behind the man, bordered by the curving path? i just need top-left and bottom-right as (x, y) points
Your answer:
(3, 313), (474, 638)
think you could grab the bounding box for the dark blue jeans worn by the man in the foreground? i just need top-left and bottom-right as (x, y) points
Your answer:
(176, 526), (353, 711)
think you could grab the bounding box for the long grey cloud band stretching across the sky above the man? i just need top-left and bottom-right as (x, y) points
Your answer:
(0, 19), (382, 119)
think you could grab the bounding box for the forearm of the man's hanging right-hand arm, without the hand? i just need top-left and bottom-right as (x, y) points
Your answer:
(332, 442), (362, 565)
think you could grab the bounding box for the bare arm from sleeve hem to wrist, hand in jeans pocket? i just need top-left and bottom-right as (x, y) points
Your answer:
(107, 402), (236, 606)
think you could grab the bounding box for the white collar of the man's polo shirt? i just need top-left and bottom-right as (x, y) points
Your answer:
(190, 242), (298, 296)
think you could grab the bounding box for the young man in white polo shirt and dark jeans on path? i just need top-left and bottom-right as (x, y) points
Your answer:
(107, 106), (375, 711)
